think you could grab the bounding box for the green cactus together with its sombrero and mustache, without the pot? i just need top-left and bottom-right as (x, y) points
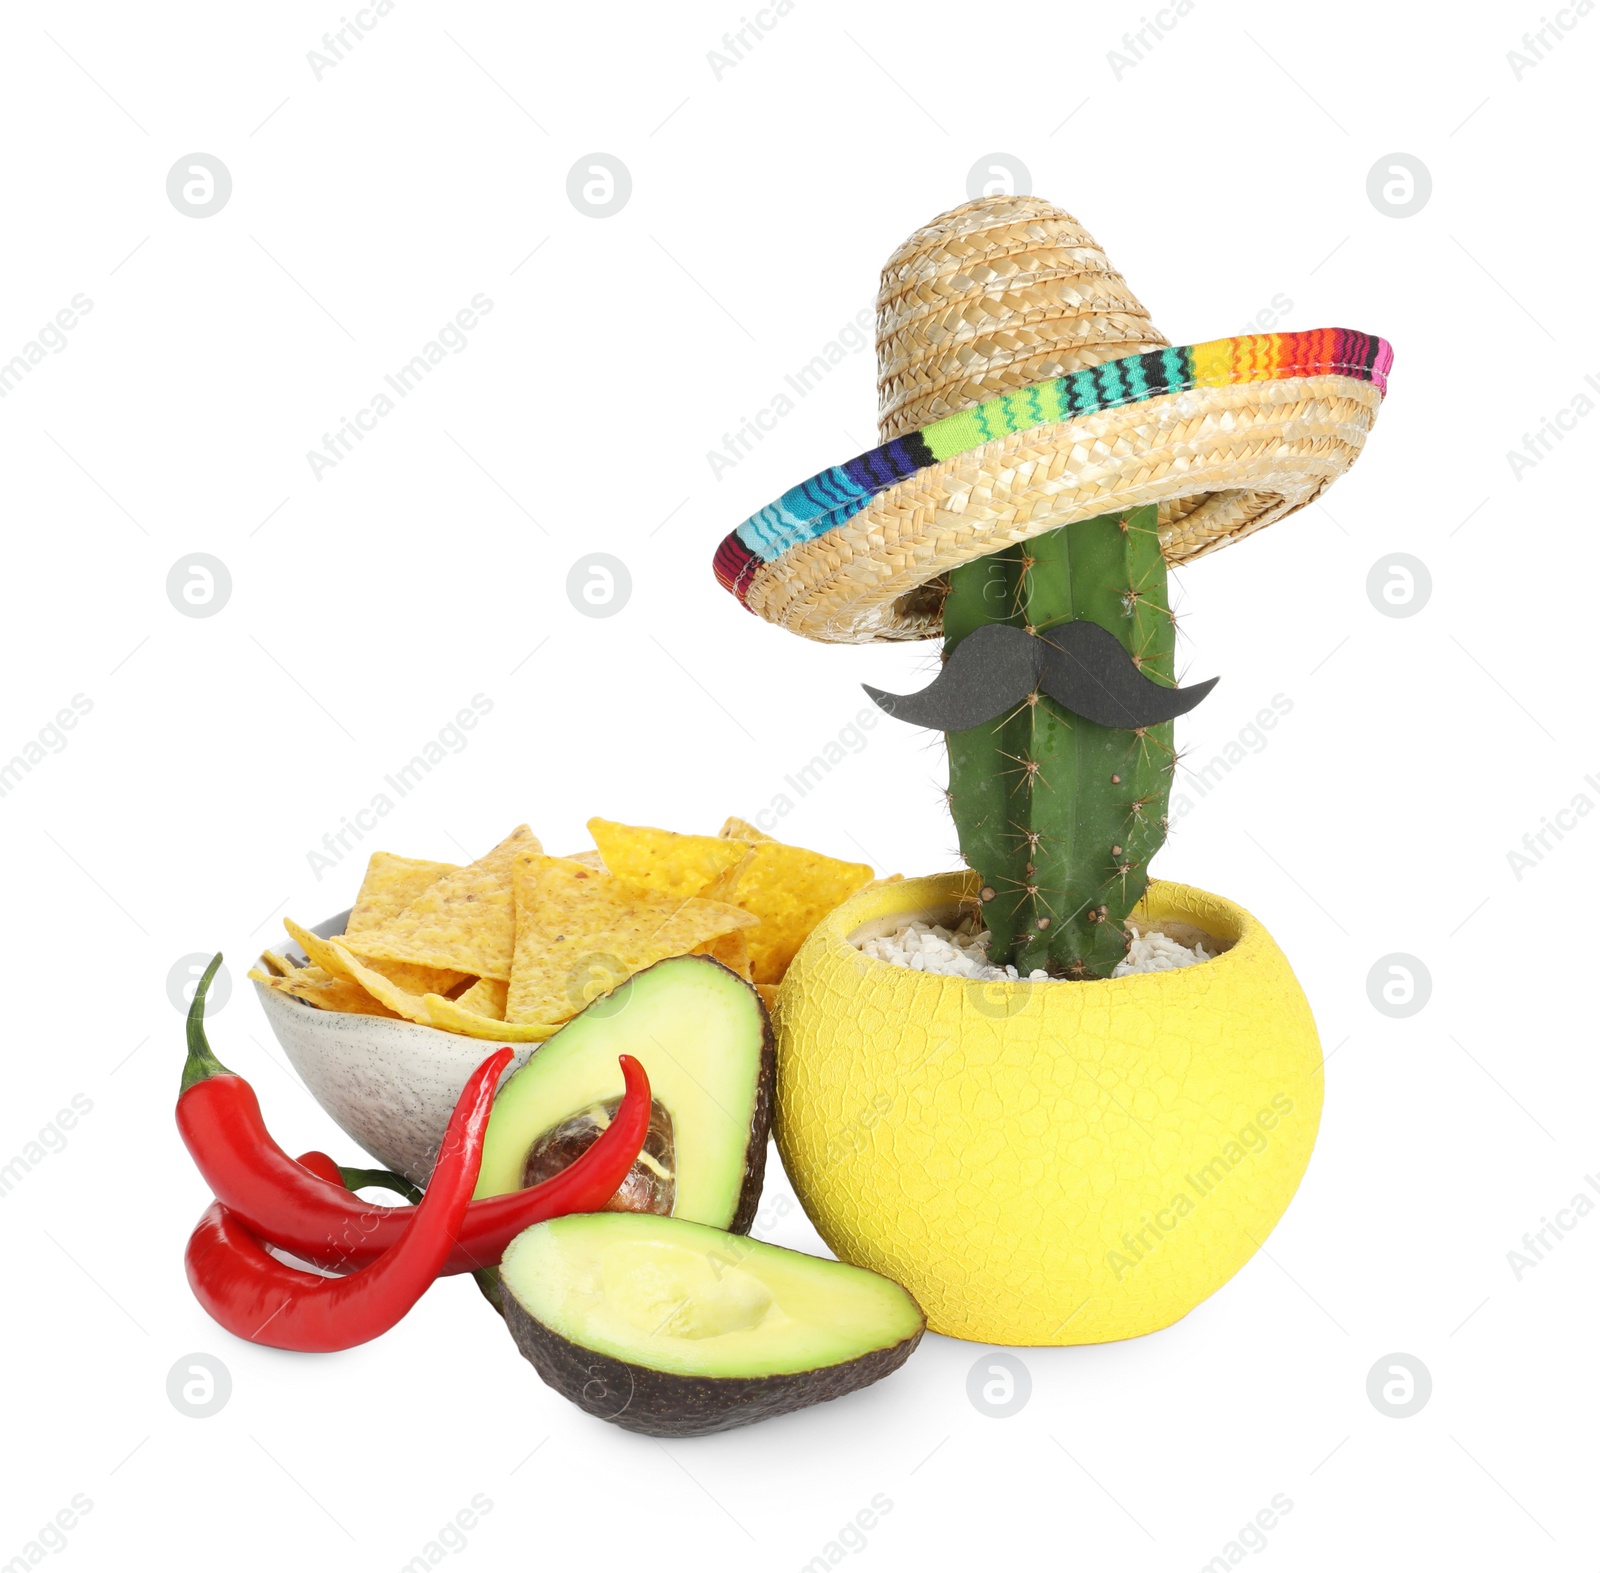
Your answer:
(714, 194), (1394, 979)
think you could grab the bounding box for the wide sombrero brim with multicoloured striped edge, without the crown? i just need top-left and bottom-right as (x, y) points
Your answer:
(715, 328), (1394, 645)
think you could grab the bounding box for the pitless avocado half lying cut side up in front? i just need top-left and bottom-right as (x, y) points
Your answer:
(499, 1213), (926, 1437)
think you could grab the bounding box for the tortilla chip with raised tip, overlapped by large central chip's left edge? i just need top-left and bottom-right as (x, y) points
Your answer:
(334, 824), (541, 985)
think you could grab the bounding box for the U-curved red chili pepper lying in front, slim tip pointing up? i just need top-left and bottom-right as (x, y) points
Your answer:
(184, 1048), (512, 1354)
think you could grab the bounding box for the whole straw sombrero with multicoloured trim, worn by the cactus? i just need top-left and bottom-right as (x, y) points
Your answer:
(715, 197), (1392, 645)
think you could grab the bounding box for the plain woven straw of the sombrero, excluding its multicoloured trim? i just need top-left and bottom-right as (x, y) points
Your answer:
(747, 197), (1381, 643)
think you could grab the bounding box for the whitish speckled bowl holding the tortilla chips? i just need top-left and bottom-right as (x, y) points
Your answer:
(256, 912), (536, 1186)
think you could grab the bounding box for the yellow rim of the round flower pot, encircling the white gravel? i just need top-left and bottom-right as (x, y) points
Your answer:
(805, 869), (1275, 994)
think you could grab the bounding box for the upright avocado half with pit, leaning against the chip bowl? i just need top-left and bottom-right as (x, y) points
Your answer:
(475, 955), (774, 1234)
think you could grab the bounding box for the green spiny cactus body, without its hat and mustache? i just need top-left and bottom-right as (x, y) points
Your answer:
(944, 506), (1176, 978)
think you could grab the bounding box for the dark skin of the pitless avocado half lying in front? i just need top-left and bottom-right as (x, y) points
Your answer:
(501, 1291), (923, 1437)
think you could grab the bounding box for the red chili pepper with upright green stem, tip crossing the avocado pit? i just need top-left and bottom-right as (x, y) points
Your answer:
(178, 957), (650, 1274)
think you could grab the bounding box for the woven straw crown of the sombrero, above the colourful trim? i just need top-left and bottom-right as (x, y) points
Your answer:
(877, 195), (1168, 442)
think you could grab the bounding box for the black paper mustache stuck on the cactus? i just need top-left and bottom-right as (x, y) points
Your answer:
(861, 619), (1218, 731)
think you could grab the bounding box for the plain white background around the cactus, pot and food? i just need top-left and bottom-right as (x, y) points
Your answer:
(0, 0), (1600, 1570)
